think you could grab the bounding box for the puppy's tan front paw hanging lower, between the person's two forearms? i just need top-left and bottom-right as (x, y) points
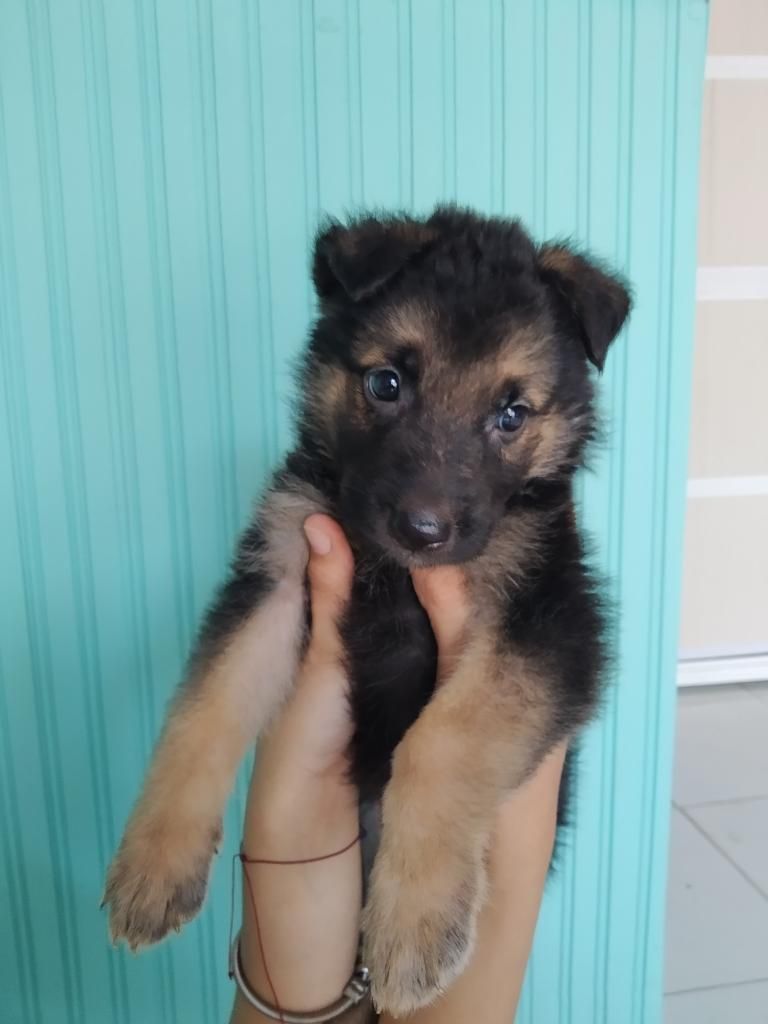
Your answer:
(362, 848), (485, 1017)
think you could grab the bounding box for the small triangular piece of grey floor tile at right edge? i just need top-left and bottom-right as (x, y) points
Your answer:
(688, 797), (768, 898)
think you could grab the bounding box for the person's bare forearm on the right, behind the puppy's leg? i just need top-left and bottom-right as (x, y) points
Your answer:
(380, 744), (566, 1024)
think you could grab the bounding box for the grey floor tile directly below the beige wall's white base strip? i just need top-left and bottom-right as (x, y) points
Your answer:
(673, 686), (768, 807)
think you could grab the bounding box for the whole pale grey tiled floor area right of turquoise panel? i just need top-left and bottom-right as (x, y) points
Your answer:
(665, 685), (768, 1024)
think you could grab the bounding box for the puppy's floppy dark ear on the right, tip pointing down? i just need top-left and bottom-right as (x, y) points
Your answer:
(539, 244), (632, 370)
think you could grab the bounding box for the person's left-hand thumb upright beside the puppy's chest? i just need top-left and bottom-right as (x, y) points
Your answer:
(304, 515), (354, 658)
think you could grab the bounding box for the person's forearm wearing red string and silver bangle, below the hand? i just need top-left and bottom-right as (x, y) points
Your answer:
(231, 765), (361, 1024)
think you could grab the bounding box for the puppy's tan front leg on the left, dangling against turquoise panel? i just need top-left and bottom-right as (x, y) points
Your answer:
(104, 479), (324, 949)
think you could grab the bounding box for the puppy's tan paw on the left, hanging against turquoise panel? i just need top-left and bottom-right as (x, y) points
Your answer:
(102, 817), (221, 950)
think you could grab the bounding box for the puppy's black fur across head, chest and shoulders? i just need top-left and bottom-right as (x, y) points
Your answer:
(203, 207), (630, 816)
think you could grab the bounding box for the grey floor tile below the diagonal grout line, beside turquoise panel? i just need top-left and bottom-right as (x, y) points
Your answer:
(665, 810), (768, 991)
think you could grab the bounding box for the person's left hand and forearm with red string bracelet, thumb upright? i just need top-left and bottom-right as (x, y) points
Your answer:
(232, 515), (362, 1024)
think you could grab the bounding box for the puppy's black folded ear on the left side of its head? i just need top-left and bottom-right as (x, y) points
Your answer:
(312, 217), (434, 302)
